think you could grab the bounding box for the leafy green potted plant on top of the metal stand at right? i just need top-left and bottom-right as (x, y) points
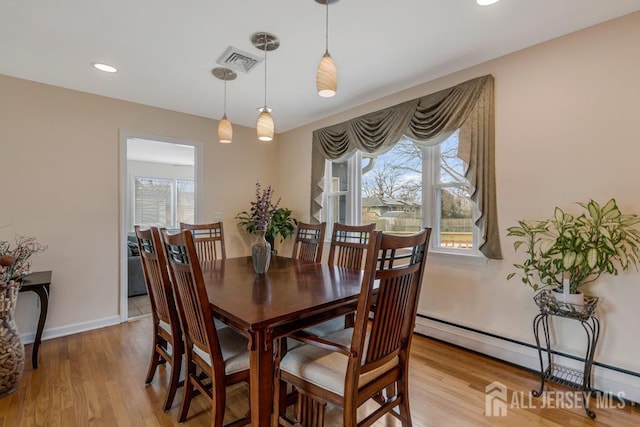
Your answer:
(507, 199), (640, 304)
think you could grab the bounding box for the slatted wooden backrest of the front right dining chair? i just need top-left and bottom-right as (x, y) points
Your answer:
(345, 228), (431, 393)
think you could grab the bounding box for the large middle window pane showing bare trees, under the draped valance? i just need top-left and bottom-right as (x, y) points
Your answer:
(362, 139), (422, 234)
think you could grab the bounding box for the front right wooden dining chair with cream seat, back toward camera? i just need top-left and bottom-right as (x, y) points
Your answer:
(274, 229), (431, 427)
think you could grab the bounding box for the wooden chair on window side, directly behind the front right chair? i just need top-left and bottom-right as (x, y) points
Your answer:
(305, 222), (376, 336)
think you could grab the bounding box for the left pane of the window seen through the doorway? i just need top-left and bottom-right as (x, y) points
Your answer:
(134, 178), (173, 227)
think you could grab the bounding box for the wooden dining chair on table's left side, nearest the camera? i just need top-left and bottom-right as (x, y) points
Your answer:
(161, 230), (251, 427)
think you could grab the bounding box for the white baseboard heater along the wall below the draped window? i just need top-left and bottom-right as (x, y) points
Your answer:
(415, 317), (640, 402)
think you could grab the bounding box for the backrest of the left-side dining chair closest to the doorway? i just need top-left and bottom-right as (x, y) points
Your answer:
(134, 225), (180, 333)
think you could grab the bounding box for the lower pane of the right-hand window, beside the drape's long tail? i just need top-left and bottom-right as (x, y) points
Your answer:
(439, 187), (473, 249)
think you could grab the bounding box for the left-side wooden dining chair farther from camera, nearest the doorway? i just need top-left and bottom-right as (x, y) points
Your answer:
(134, 225), (184, 411)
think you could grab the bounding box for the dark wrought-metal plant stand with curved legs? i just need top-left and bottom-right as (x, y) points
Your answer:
(532, 290), (600, 418)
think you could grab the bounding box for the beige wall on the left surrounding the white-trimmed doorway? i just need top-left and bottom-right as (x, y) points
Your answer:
(0, 76), (278, 337)
